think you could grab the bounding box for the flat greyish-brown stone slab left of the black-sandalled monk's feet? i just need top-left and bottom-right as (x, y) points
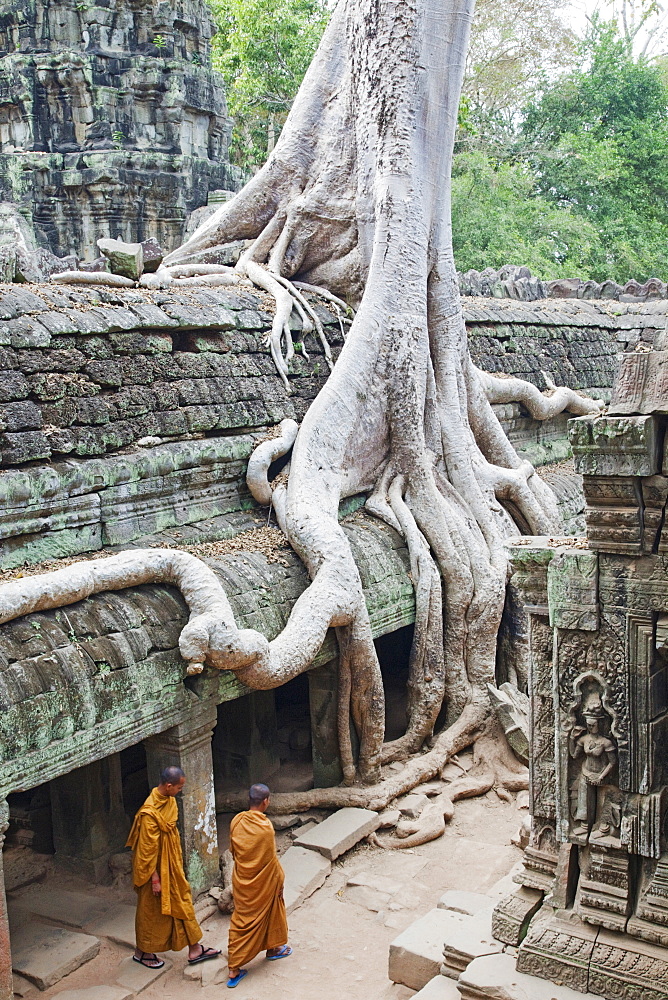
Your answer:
(12, 921), (100, 990)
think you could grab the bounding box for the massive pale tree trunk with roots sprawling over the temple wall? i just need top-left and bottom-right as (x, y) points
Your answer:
(1, 0), (598, 807)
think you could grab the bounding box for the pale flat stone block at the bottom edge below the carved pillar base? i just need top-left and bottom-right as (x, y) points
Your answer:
(457, 955), (600, 1000)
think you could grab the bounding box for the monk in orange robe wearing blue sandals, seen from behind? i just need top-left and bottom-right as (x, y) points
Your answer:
(227, 785), (292, 987)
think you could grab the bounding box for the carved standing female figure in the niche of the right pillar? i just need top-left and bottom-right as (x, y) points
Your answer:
(568, 679), (620, 840)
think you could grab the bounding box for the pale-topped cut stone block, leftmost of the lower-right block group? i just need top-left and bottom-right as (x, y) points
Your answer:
(388, 909), (467, 990)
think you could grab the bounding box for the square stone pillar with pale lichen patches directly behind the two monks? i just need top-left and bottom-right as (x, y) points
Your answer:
(144, 705), (219, 896)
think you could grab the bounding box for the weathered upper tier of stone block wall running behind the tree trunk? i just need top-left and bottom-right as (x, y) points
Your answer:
(0, 285), (632, 569)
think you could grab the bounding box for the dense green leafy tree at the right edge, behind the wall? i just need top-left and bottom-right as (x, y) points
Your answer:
(521, 21), (668, 281)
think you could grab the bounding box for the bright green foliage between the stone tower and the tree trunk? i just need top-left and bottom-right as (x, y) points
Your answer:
(211, 0), (329, 169)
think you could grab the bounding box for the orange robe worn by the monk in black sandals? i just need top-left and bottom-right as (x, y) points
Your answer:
(127, 788), (202, 953)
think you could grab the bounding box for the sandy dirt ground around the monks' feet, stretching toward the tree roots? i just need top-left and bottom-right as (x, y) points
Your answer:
(33, 792), (522, 1000)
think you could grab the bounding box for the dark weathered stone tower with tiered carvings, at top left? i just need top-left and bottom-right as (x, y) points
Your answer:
(0, 0), (239, 256)
